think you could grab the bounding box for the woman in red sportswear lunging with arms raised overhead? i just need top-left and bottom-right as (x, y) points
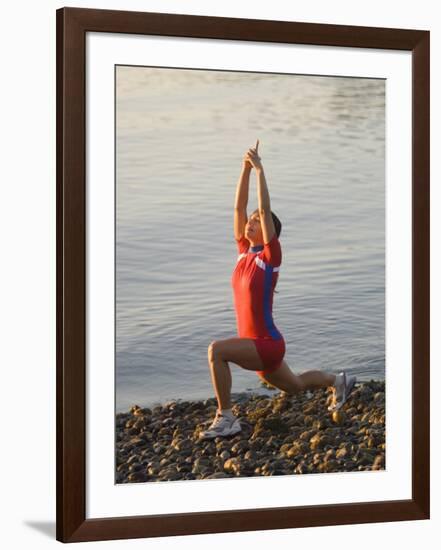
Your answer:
(201, 140), (356, 439)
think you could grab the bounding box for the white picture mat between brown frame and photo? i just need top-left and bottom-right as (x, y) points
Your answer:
(86, 33), (412, 518)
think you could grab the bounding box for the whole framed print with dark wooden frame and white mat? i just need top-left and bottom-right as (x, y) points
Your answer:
(57, 7), (430, 542)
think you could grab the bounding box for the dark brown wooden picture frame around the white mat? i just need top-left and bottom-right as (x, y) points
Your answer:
(56, 8), (430, 542)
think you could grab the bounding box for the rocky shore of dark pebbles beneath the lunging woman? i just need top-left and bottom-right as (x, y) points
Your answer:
(116, 380), (385, 483)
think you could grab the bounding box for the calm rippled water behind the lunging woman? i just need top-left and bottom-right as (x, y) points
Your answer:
(116, 67), (385, 411)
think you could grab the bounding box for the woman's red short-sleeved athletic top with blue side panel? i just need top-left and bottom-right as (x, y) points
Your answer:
(231, 233), (283, 340)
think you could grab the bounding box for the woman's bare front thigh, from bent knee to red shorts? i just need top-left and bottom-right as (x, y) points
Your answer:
(208, 338), (265, 371)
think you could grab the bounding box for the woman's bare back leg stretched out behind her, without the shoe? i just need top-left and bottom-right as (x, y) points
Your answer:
(261, 361), (336, 394)
